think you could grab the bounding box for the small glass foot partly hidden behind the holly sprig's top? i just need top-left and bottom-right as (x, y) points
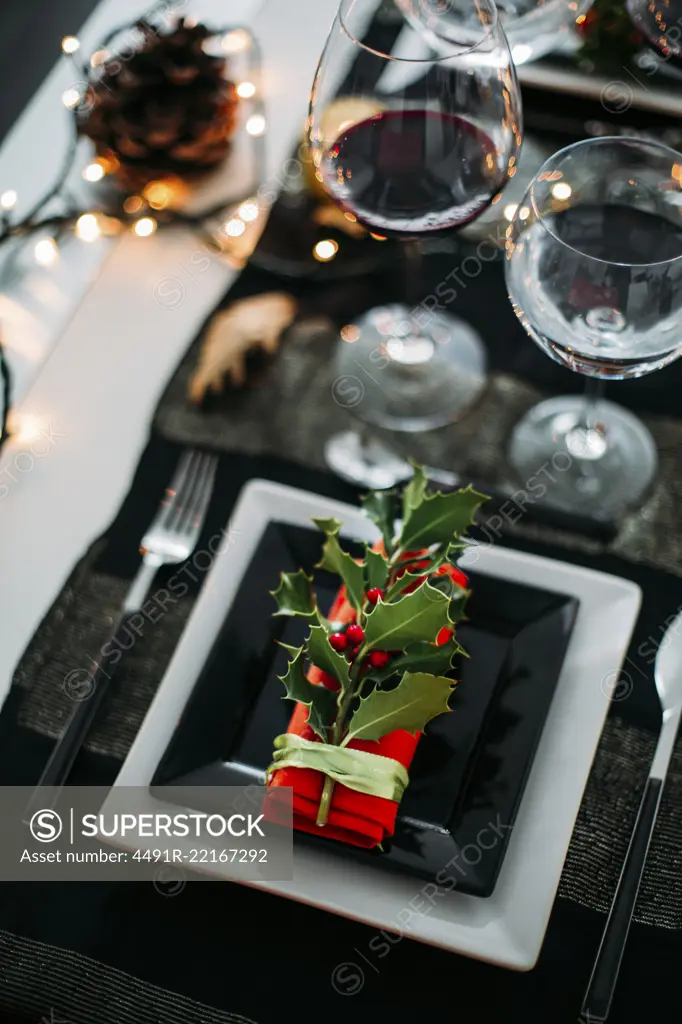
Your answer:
(325, 430), (413, 490)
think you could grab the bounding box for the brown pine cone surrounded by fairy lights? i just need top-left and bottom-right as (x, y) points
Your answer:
(78, 18), (239, 189)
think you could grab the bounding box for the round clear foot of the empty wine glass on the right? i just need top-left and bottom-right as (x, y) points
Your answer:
(508, 396), (658, 519)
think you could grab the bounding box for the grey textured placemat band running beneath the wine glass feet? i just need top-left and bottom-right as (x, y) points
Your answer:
(156, 323), (682, 575)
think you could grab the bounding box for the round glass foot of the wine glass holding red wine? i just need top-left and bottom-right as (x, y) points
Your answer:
(333, 304), (487, 432)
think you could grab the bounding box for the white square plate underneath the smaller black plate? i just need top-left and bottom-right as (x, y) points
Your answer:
(109, 480), (641, 971)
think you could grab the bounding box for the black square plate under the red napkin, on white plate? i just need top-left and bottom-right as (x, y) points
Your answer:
(153, 522), (578, 896)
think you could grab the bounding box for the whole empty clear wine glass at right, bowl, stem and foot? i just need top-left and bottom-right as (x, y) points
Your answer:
(506, 136), (682, 517)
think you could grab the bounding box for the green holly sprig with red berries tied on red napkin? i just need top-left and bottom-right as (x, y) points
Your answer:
(272, 465), (486, 824)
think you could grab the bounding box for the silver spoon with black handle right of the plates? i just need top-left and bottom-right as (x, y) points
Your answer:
(581, 612), (682, 1024)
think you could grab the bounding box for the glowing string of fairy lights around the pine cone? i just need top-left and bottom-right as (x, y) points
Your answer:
(0, 15), (266, 446)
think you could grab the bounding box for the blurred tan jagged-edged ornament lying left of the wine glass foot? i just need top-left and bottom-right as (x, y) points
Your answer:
(189, 292), (298, 403)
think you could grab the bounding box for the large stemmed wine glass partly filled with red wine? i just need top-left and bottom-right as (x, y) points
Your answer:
(308, 0), (521, 485)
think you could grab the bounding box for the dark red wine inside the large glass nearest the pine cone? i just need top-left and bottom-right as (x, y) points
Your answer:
(319, 110), (507, 239)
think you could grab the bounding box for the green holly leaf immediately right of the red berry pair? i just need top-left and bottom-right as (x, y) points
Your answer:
(365, 578), (451, 650)
